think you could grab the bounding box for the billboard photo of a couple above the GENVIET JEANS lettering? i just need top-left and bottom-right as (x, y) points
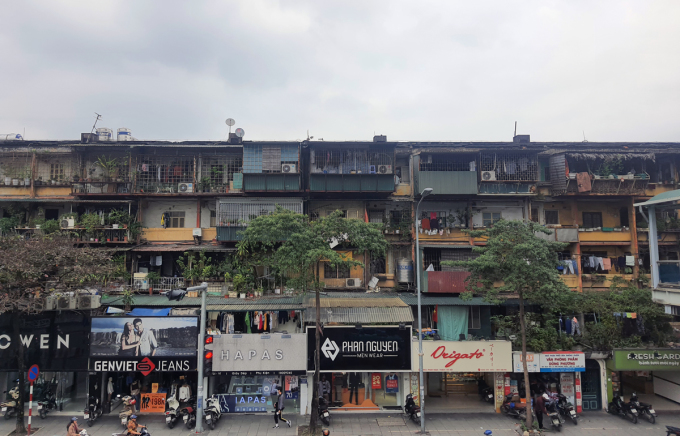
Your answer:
(90, 316), (198, 357)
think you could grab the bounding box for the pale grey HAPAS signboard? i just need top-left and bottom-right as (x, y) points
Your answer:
(213, 333), (307, 375)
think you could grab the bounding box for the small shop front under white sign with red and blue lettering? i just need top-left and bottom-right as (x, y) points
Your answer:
(505, 351), (586, 413)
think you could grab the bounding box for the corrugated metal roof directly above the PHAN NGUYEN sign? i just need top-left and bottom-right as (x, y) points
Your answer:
(305, 307), (413, 324)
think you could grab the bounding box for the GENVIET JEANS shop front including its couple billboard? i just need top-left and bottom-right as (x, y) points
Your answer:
(90, 316), (198, 414)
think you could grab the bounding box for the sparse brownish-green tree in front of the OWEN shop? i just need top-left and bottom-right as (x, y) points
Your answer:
(0, 234), (116, 434)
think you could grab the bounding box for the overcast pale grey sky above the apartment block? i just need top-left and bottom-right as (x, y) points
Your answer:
(0, 0), (680, 141)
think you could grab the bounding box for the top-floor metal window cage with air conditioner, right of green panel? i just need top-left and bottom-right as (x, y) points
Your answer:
(479, 152), (538, 182)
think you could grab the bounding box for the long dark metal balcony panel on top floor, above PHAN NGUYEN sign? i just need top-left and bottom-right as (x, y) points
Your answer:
(309, 174), (394, 193)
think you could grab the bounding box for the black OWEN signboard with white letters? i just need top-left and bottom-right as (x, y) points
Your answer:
(0, 311), (90, 371)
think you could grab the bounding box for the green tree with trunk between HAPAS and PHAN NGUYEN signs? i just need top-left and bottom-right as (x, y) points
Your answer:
(239, 207), (389, 434)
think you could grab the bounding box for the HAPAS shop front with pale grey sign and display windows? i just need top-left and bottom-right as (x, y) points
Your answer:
(208, 333), (307, 414)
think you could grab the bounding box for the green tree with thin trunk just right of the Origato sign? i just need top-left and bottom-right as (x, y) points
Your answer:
(442, 220), (574, 427)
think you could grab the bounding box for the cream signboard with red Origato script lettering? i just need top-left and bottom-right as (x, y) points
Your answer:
(418, 341), (512, 372)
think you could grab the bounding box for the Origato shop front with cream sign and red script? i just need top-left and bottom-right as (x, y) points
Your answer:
(410, 341), (512, 412)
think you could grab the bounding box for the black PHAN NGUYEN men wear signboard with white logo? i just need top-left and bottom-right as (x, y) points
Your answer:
(307, 326), (412, 372)
